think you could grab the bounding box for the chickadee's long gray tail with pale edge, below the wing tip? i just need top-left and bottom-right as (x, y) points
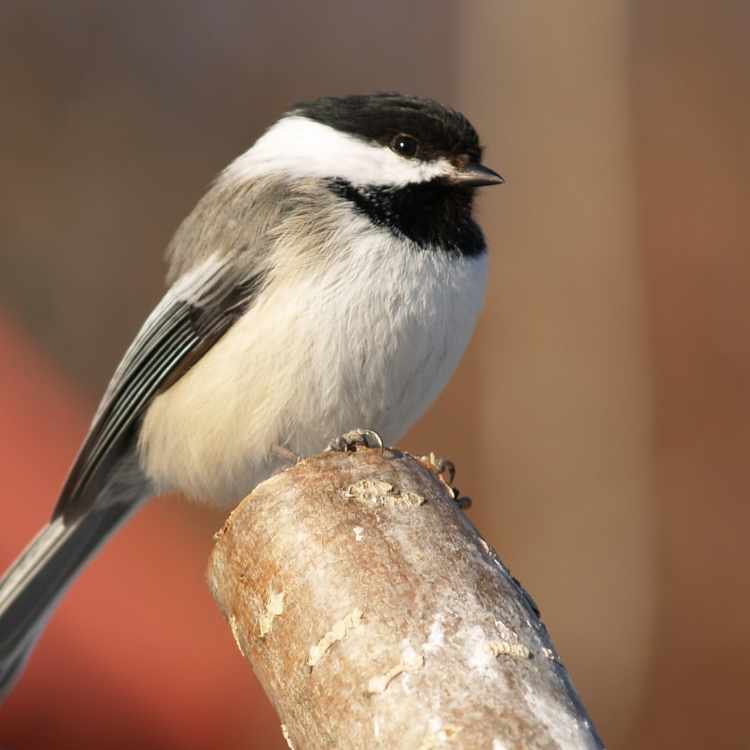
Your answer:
(0, 499), (140, 702)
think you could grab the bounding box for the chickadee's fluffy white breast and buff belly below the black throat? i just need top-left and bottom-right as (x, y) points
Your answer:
(140, 223), (486, 504)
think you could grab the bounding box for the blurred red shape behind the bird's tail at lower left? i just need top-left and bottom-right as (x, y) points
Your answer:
(0, 316), (286, 750)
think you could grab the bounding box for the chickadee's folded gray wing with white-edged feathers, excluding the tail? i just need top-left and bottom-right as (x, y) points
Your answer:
(53, 257), (264, 521)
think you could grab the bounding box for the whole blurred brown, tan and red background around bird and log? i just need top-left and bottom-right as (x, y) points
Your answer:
(0, 0), (750, 750)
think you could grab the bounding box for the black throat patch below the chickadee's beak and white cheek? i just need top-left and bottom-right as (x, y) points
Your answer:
(328, 179), (485, 257)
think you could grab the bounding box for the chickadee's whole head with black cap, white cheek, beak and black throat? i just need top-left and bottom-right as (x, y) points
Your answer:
(224, 93), (503, 256)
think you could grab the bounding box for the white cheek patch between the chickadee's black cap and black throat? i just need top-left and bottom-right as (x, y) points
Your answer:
(222, 115), (454, 187)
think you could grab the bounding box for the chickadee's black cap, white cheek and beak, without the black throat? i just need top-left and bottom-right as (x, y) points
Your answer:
(230, 93), (503, 189)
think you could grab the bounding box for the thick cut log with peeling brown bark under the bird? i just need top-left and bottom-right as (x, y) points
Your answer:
(208, 448), (603, 750)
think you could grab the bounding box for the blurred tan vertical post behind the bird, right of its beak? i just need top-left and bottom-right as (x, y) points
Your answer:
(457, 0), (654, 738)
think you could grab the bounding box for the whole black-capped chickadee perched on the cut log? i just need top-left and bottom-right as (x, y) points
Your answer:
(0, 93), (503, 695)
